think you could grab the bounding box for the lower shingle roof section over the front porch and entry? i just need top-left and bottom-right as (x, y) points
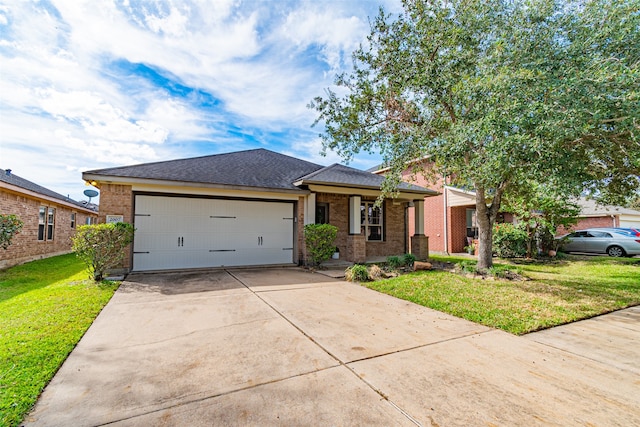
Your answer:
(299, 163), (435, 193)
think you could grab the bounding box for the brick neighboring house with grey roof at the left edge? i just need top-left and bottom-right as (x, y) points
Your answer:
(0, 169), (98, 268)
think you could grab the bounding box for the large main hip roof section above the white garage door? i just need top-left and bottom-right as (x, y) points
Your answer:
(84, 148), (322, 190)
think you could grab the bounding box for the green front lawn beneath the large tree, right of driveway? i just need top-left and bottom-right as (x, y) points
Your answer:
(363, 256), (640, 334)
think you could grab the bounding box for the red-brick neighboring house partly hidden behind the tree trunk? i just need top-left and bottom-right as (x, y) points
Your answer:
(369, 157), (513, 253)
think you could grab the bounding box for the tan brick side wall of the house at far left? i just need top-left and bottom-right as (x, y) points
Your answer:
(0, 190), (97, 268)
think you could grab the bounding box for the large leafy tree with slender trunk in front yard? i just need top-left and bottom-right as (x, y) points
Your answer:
(310, 0), (640, 268)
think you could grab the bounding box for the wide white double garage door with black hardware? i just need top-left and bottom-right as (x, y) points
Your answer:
(133, 195), (294, 271)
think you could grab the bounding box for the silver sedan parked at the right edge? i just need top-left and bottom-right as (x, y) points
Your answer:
(556, 228), (640, 257)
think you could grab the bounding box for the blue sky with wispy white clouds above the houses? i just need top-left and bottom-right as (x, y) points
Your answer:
(0, 0), (401, 202)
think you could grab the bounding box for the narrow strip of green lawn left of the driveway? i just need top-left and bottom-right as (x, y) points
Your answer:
(0, 254), (118, 426)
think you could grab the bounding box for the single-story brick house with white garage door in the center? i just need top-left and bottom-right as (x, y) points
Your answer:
(83, 149), (436, 271)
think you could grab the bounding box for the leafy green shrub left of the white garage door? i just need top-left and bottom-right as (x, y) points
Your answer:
(72, 222), (134, 282)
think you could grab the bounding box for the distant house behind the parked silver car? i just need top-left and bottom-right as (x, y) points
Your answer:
(558, 198), (640, 234)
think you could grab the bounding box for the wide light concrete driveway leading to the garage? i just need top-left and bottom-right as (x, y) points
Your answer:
(25, 269), (640, 426)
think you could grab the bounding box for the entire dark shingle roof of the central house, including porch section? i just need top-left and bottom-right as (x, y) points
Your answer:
(83, 148), (430, 192)
